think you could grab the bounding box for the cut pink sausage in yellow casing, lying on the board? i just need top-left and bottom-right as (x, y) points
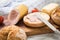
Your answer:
(8, 4), (28, 25)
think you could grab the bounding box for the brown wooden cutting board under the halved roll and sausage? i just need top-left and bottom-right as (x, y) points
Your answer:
(1, 15), (60, 36)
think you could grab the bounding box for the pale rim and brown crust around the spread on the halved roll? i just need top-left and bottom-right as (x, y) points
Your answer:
(23, 12), (50, 27)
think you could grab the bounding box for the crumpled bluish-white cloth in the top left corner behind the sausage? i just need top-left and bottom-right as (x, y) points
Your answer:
(0, 0), (24, 15)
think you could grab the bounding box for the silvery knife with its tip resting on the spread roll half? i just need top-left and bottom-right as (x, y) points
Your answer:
(36, 14), (60, 34)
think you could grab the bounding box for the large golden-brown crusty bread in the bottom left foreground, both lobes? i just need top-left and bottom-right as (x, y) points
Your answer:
(0, 25), (27, 40)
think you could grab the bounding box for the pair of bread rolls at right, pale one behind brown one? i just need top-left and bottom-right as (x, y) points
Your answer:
(42, 3), (60, 25)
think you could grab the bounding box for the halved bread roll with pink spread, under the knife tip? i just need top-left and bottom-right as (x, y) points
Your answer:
(23, 12), (50, 27)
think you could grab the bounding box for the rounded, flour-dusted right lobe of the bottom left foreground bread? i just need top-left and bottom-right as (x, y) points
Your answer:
(7, 29), (26, 40)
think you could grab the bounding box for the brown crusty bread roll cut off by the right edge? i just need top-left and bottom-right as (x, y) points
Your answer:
(51, 8), (60, 25)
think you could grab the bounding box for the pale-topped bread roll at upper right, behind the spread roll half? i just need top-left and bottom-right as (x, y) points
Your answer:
(42, 3), (59, 15)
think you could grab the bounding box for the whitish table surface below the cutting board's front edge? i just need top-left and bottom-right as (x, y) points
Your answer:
(27, 33), (60, 40)
